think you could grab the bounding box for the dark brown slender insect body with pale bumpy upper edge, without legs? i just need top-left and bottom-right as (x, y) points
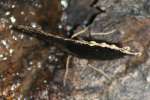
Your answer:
(13, 25), (140, 60)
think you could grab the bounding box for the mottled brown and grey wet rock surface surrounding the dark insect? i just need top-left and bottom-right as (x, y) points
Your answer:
(0, 0), (150, 100)
